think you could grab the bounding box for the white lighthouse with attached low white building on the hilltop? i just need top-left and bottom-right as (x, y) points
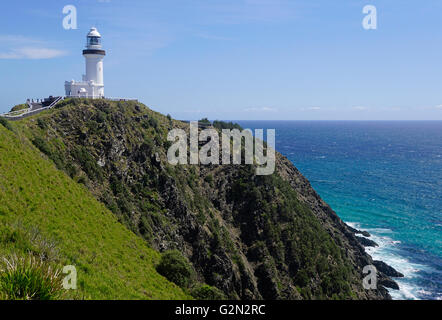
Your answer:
(65, 28), (106, 99)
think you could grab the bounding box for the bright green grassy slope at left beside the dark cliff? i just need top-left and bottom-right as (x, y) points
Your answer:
(0, 124), (189, 299)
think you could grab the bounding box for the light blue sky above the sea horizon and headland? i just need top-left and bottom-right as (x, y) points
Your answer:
(0, 0), (442, 120)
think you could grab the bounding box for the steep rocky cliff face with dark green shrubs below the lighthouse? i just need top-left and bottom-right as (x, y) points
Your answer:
(13, 99), (389, 299)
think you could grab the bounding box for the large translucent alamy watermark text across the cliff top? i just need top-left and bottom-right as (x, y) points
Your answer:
(167, 121), (275, 175)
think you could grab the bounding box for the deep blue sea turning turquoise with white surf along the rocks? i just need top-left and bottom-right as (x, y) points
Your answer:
(237, 121), (442, 299)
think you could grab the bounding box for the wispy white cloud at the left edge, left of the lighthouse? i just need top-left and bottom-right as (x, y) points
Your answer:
(0, 35), (66, 60)
